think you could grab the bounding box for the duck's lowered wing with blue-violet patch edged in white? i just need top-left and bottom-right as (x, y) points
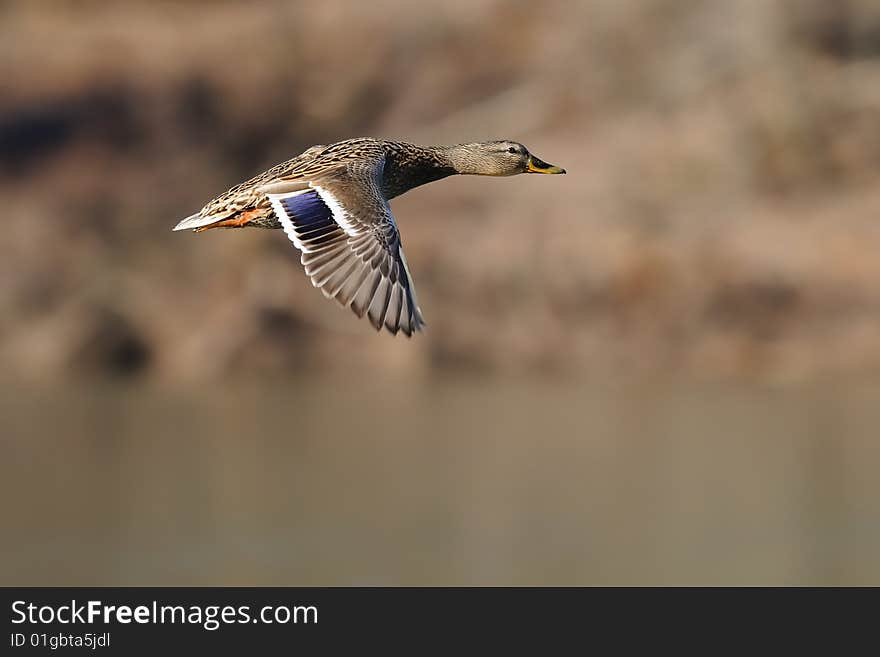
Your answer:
(267, 159), (425, 336)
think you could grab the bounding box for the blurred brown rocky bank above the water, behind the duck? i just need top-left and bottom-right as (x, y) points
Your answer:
(0, 0), (880, 381)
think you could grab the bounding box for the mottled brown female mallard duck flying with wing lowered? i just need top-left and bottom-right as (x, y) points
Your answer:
(173, 137), (565, 337)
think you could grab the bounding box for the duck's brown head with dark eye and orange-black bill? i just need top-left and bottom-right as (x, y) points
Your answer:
(448, 140), (565, 176)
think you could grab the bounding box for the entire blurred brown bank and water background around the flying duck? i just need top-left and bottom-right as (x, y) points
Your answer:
(0, 0), (880, 585)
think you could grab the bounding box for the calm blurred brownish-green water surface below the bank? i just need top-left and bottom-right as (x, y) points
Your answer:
(0, 380), (880, 585)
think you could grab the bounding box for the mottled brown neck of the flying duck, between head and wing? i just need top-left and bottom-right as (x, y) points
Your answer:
(382, 142), (463, 199)
